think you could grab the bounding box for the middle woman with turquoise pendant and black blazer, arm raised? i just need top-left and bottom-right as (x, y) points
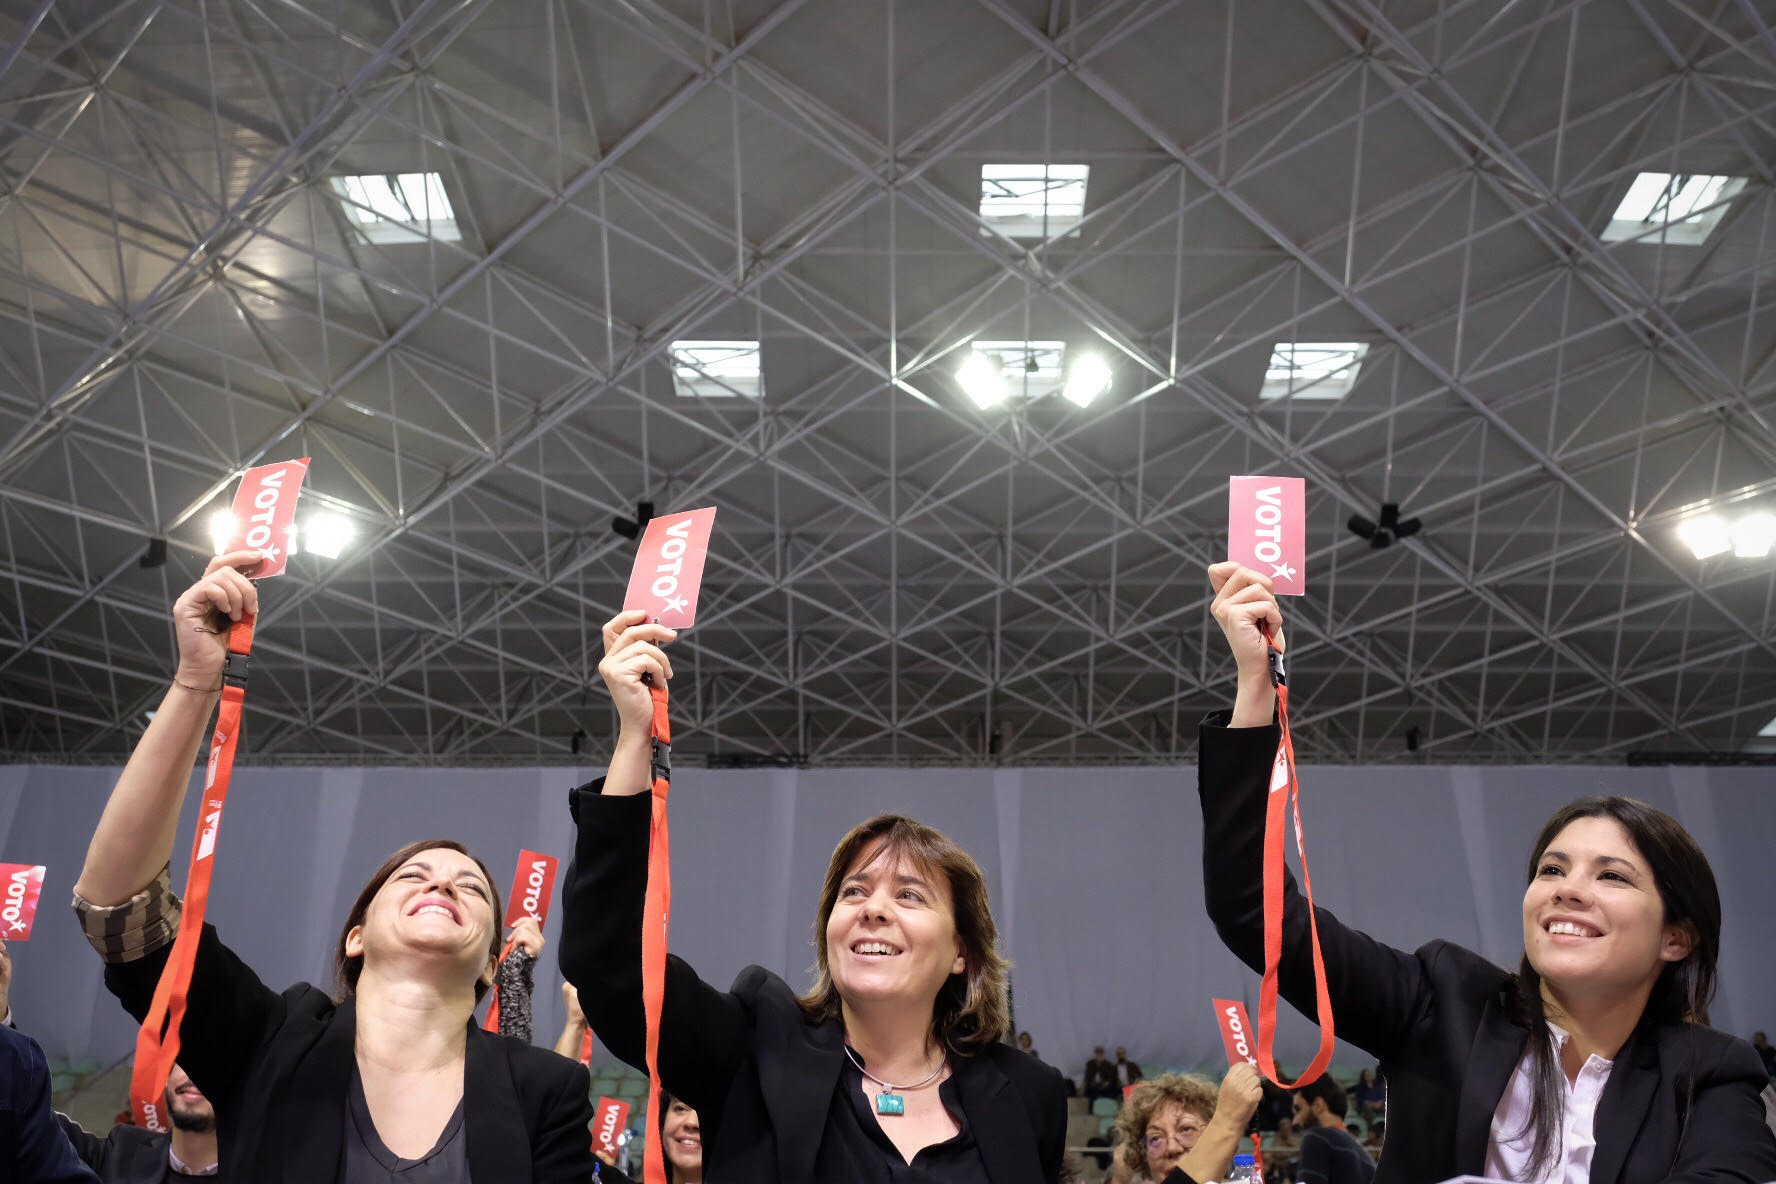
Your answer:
(561, 612), (1067, 1184)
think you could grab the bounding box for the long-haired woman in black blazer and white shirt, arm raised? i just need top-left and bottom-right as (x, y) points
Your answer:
(1199, 563), (1776, 1184)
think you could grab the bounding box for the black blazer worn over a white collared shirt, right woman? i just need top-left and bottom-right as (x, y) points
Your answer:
(1199, 715), (1776, 1184)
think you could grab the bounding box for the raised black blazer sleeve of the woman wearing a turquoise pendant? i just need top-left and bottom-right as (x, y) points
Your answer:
(561, 779), (751, 1125)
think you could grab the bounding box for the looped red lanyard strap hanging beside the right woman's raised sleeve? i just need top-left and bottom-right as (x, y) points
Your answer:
(1257, 641), (1337, 1088)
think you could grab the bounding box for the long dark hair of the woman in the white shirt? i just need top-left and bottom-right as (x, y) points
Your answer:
(1511, 797), (1721, 1179)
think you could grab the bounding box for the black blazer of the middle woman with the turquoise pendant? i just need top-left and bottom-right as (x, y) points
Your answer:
(561, 779), (1067, 1184)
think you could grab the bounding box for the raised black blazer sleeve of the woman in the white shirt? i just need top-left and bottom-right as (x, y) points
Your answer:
(1199, 717), (1430, 1062)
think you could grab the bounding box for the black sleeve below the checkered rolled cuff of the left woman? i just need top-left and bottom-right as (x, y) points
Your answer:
(105, 921), (288, 1109)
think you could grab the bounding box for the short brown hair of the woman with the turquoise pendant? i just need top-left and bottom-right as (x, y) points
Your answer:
(801, 815), (1011, 1053)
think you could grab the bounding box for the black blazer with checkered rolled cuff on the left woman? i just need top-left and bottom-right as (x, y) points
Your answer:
(105, 925), (593, 1184)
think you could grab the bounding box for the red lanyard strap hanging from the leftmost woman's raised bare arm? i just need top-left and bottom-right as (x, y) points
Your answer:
(130, 616), (254, 1131)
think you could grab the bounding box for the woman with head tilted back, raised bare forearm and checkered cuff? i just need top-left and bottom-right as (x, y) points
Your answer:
(75, 552), (591, 1184)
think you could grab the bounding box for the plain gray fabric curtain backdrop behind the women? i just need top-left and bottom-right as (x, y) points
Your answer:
(0, 765), (1776, 1077)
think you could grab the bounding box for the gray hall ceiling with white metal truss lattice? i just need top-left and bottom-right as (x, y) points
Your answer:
(0, 0), (1776, 765)
